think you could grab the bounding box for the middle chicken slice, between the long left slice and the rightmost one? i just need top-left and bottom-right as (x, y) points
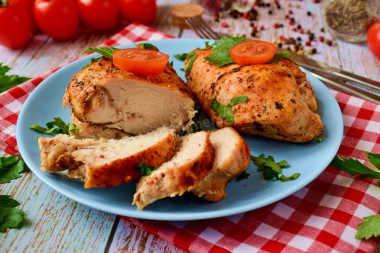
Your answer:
(132, 131), (214, 209)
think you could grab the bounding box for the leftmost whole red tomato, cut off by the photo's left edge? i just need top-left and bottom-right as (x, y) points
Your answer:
(0, 3), (32, 49)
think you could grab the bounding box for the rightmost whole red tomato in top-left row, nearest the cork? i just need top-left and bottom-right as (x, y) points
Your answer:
(119, 0), (157, 25)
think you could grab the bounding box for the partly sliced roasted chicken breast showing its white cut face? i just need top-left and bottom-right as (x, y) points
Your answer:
(63, 57), (195, 135)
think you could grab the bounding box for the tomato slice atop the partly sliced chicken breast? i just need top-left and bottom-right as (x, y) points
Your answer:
(112, 48), (169, 76)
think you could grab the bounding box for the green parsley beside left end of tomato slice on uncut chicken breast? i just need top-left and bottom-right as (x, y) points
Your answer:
(205, 37), (248, 66)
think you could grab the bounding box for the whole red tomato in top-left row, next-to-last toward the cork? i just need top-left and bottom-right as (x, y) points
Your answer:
(77, 0), (119, 31)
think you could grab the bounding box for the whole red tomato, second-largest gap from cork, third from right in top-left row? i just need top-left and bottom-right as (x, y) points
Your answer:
(34, 0), (79, 40)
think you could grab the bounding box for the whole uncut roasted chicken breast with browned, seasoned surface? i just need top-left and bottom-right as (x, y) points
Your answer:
(185, 49), (323, 142)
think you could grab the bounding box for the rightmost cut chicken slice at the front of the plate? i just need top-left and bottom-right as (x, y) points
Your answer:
(192, 127), (251, 202)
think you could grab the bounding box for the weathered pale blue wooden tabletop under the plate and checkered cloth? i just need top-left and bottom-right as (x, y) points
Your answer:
(0, 0), (380, 252)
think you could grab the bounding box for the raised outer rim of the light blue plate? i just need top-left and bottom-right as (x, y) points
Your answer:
(16, 38), (343, 221)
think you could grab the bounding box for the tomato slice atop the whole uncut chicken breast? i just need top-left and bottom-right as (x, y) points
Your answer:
(229, 40), (277, 65)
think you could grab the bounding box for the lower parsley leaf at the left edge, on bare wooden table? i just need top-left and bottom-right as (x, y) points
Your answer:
(0, 195), (24, 233)
